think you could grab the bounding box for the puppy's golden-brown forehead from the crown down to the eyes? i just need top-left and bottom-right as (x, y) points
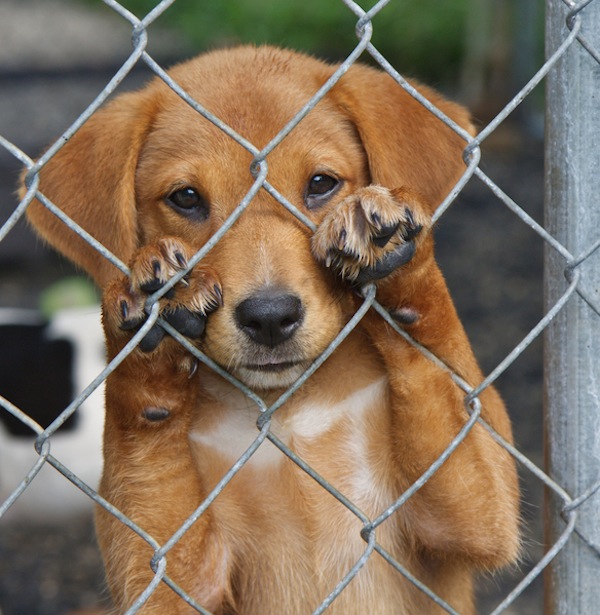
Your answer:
(138, 48), (364, 202)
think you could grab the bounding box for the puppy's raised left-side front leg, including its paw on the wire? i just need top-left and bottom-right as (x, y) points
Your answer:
(97, 239), (228, 615)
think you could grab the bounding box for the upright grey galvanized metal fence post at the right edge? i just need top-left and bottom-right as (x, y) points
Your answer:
(544, 0), (600, 615)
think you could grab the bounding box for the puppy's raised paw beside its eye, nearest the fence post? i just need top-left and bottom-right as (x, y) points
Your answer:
(312, 186), (430, 285)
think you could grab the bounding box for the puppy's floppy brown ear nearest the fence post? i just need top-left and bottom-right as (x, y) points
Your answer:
(331, 65), (475, 211)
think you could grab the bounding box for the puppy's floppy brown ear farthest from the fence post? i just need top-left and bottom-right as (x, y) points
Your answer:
(20, 91), (153, 287)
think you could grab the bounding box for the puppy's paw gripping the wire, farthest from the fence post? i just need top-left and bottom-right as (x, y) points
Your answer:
(104, 238), (223, 352)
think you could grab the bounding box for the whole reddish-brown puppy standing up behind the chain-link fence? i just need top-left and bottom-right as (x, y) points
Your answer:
(23, 47), (518, 615)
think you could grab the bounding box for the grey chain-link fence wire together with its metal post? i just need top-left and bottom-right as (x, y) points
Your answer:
(0, 0), (600, 614)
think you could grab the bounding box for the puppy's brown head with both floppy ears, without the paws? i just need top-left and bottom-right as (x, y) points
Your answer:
(22, 47), (470, 387)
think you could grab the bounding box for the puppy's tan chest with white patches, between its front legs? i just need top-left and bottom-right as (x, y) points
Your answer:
(190, 378), (412, 614)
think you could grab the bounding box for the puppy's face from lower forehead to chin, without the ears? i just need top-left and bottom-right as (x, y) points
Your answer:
(136, 78), (368, 388)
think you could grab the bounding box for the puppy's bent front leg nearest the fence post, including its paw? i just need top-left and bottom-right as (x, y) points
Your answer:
(313, 186), (518, 569)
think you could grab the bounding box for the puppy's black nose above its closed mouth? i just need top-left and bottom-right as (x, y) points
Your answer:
(235, 289), (304, 348)
